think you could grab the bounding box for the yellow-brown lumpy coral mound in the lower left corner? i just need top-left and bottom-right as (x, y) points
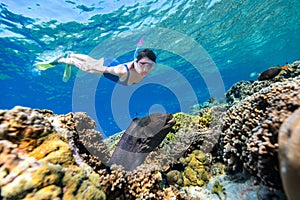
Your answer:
(0, 107), (105, 199)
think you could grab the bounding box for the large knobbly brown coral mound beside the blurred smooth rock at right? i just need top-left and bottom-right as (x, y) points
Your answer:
(220, 78), (300, 188)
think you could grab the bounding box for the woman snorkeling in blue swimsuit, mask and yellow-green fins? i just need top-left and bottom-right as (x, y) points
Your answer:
(36, 49), (156, 85)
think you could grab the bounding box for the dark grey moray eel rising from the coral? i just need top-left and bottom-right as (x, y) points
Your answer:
(109, 113), (175, 171)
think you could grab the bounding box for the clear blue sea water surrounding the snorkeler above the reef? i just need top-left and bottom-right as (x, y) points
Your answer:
(0, 0), (300, 135)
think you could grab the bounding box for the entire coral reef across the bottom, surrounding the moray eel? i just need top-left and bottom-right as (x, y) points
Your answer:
(0, 61), (300, 200)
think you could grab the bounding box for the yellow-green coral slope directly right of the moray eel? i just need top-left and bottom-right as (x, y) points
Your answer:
(145, 106), (224, 170)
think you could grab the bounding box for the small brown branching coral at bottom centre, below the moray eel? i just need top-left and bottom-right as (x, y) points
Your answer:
(100, 165), (178, 200)
